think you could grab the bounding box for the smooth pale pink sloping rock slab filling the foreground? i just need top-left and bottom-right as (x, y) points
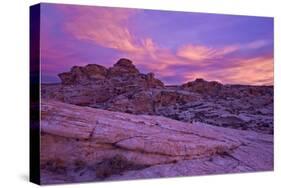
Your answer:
(41, 99), (273, 184)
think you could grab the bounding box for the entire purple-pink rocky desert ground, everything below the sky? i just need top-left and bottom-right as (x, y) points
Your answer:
(40, 58), (273, 184)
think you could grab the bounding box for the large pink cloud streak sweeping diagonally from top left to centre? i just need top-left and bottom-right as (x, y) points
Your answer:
(62, 7), (187, 74)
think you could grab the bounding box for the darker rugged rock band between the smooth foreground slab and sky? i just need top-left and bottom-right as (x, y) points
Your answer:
(41, 59), (273, 134)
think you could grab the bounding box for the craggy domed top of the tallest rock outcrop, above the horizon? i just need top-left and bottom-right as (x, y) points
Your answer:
(58, 58), (164, 88)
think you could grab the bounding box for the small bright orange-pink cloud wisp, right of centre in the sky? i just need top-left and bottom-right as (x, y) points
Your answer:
(177, 45), (239, 61)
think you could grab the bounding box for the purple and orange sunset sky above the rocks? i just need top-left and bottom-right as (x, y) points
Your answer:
(40, 4), (274, 85)
